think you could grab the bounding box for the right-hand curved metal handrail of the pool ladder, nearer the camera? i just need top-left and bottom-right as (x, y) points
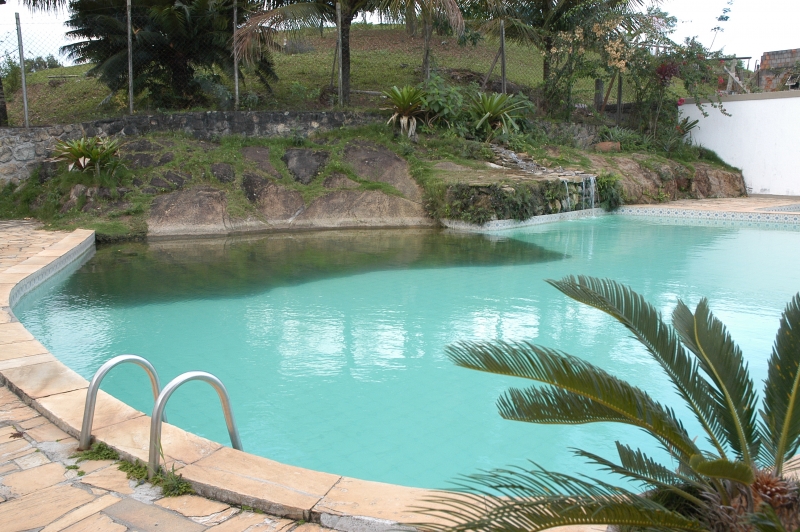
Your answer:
(147, 371), (243, 478)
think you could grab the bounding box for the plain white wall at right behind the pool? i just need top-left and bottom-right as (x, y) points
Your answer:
(681, 91), (800, 196)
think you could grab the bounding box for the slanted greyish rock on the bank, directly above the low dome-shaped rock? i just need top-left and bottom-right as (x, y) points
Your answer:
(344, 143), (422, 202)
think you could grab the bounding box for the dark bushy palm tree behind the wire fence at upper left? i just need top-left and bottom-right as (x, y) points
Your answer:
(63, 0), (275, 108)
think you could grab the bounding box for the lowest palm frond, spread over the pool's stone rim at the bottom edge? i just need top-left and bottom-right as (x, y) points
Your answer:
(421, 466), (703, 532)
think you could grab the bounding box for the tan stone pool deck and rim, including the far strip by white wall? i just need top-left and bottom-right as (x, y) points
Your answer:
(0, 196), (800, 532)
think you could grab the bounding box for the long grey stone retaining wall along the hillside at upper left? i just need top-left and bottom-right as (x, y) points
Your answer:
(0, 111), (383, 187)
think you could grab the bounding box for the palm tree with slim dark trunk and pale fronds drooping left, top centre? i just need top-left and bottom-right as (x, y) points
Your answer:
(235, 0), (377, 105)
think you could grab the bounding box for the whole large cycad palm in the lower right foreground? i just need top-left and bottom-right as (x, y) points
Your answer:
(429, 277), (800, 532)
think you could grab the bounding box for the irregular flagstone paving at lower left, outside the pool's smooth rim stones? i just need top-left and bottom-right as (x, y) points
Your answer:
(0, 387), (321, 532)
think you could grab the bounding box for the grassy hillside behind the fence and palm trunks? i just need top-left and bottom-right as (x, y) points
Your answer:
(1, 24), (608, 126)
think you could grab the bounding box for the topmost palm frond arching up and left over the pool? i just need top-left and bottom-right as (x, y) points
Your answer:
(547, 276), (725, 458)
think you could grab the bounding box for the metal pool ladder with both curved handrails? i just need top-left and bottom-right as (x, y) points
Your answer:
(78, 355), (243, 478)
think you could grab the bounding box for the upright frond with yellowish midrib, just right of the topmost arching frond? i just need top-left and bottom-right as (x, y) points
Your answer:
(672, 298), (761, 466)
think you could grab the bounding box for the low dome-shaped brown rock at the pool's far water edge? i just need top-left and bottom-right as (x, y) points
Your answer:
(292, 190), (433, 227)
